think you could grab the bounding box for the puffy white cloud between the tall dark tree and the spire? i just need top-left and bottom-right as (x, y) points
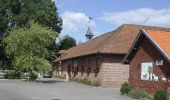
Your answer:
(61, 11), (95, 34)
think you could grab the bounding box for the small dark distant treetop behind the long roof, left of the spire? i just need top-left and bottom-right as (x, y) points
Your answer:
(58, 35), (76, 50)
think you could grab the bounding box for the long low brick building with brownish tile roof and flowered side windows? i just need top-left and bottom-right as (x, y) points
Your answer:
(54, 24), (168, 87)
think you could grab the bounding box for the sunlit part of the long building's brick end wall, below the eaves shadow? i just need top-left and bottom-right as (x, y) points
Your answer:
(100, 63), (129, 87)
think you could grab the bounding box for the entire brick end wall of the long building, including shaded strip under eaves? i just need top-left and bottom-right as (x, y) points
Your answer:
(100, 54), (129, 87)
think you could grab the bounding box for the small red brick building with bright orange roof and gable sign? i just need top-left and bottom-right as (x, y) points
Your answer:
(124, 30), (170, 93)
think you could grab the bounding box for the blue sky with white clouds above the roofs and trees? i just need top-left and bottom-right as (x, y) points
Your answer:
(55, 0), (170, 42)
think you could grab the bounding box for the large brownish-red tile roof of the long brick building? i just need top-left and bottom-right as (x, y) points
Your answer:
(57, 24), (170, 61)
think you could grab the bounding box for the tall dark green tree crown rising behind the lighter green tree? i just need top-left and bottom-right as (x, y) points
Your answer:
(0, 0), (62, 33)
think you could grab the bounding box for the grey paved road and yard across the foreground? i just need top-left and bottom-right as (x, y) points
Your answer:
(0, 80), (130, 100)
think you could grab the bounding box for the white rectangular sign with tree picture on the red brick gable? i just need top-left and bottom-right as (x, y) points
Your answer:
(141, 62), (153, 80)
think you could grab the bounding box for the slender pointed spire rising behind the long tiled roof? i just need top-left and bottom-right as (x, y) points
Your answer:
(85, 17), (94, 40)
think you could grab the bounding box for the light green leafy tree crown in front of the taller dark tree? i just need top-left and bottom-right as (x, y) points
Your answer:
(3, 23), (56, 78)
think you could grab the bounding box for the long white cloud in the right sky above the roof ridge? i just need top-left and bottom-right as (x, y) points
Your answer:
(100, 8), (170, 27)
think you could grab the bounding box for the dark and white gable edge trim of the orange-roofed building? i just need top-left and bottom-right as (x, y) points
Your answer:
(123, 29), (170, 64)
